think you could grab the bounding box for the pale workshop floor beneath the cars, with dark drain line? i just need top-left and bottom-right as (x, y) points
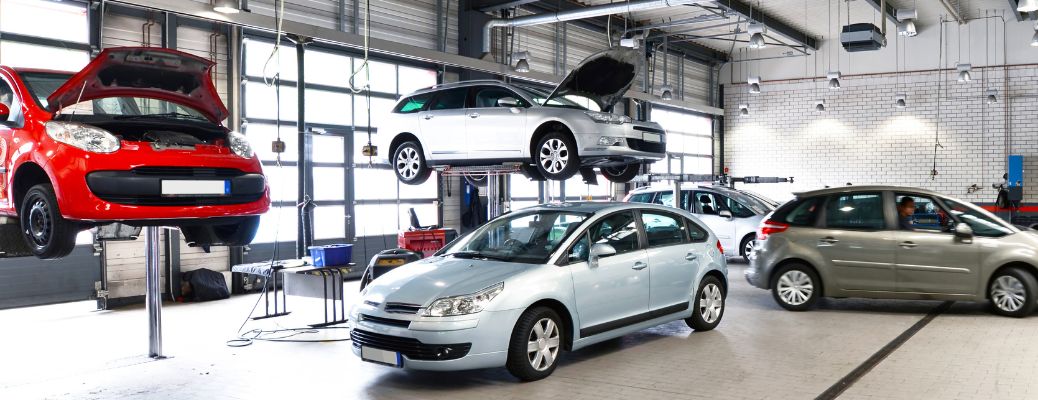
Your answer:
(0, 263), (1038, 400)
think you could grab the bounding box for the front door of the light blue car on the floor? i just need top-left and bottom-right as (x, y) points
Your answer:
(570, 211), (649, 337)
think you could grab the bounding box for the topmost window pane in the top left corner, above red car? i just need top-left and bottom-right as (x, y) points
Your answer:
(0, 0), (90, 42)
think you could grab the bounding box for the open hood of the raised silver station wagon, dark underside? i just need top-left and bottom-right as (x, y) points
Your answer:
(544, 47), (644, 111)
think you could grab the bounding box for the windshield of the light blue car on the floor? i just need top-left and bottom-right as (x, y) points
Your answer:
(440, 210), (588, 264)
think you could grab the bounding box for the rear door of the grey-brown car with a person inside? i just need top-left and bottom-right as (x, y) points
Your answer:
(815, 192), (897, 291)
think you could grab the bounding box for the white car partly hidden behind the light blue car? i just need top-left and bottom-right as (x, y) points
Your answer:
(624, 185), (777, 262)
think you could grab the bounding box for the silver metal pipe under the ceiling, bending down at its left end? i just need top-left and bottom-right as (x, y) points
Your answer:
(483, 0), (713, 56)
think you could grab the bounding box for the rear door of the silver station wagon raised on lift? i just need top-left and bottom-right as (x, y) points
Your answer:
(418, 87), (469, 161)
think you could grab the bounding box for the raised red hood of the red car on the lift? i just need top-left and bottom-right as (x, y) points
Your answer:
(47, 47), (228, 124)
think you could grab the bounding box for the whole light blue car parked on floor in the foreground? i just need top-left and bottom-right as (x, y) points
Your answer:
(349, 203), (728, 380)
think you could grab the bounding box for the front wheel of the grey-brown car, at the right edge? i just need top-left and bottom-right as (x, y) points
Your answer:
(987, 267), (1038, 318)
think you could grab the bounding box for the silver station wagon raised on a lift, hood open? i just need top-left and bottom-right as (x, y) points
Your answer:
(378, 48), (666, 185)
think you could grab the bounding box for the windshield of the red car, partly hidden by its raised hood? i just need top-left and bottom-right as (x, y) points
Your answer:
(21, 73), (208, 121)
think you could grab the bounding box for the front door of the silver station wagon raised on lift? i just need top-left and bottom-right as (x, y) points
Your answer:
(465, 86), (529, 160)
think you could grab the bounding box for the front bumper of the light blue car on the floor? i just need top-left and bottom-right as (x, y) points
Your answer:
(349, 304), (522, 371)
